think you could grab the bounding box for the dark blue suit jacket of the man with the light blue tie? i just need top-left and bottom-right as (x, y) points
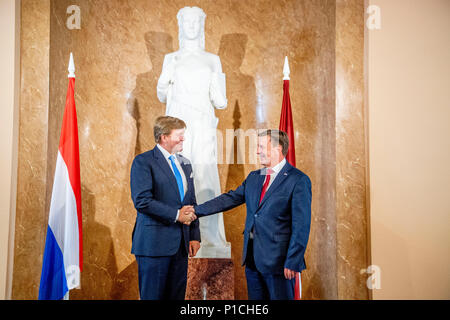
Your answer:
(130, 147), (200, 257)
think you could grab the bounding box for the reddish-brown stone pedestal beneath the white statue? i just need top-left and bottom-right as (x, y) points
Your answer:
(186, 258), (234, 300)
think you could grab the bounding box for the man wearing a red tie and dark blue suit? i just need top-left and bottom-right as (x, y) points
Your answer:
(194, 130), (311, 300)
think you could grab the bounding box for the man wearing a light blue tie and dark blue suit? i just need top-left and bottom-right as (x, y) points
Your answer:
(130, 116), (200, 300)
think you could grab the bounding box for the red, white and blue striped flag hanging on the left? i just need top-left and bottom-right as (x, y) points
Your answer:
(39, 53), (83, 300)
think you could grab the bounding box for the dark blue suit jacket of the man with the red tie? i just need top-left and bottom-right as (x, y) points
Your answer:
(194, 162), (311, 274)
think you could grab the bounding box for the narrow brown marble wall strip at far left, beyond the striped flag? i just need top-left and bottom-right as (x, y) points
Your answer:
(11, 0), (50, 299)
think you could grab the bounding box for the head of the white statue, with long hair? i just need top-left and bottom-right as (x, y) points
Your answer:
(177, 7), (206, 49)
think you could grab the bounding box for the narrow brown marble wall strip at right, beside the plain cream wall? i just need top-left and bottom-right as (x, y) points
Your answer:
(336, 0), (370, 299)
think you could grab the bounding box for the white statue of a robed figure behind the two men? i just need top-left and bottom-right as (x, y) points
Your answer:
(157, 7), (231, 258)
